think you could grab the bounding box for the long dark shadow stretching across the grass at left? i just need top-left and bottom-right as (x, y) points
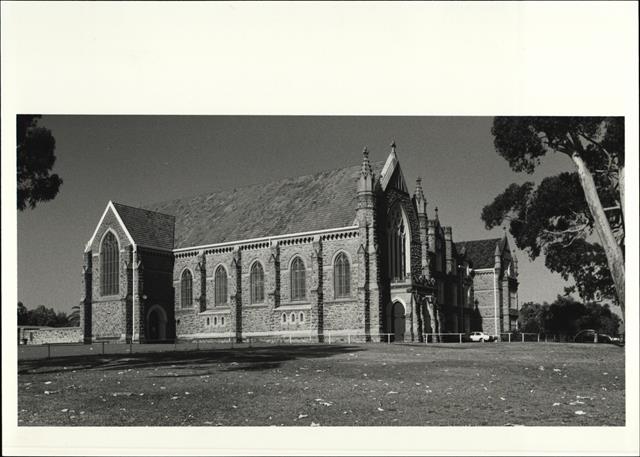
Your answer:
(18, 345), (363, 377)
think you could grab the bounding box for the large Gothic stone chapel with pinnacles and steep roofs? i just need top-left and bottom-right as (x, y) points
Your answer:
(81, 143), (518, 343)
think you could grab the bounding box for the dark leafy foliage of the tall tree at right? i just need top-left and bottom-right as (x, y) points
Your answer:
(482, 117), (624, 300)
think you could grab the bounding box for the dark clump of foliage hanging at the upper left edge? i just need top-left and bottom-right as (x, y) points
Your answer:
(16, 115), (62, 211)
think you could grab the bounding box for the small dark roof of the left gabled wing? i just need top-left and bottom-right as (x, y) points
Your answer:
(113, 202), (175, 249)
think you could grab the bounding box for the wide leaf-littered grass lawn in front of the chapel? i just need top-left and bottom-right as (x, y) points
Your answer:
(18, 343), (625, 426)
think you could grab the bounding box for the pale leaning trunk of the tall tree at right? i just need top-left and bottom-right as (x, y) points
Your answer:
(571, 152), (625, 322)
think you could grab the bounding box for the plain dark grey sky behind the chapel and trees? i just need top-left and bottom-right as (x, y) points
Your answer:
(18, 116), (571, 312)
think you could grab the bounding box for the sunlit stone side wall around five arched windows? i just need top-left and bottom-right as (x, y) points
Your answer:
(173, 230), (365, 339)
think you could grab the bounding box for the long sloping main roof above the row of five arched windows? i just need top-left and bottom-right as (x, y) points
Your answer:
(142, 162), (383, 249)
